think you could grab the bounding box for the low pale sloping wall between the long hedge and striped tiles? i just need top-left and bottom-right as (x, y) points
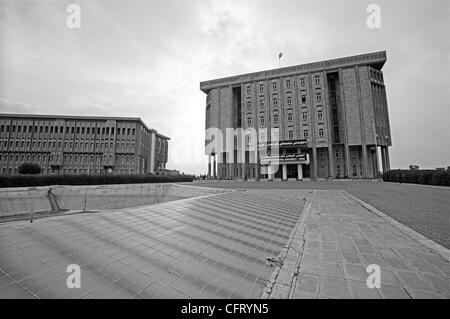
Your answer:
(0, 183), (228, 217)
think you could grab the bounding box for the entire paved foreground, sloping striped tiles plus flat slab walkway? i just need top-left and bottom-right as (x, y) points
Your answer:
(0, 189), (449, 298)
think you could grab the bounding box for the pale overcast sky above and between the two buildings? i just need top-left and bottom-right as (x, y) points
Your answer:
(0, 0), (450, 174)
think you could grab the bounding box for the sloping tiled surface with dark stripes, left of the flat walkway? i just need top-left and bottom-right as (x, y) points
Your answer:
(0, 191), (306, 298)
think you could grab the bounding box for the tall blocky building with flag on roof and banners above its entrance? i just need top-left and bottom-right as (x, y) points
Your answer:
(200, 51), (392, 180)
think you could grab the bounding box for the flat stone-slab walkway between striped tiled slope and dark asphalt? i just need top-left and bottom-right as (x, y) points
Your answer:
(266, 191), (449, 298)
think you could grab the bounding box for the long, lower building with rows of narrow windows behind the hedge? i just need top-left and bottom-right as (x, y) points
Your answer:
(0, 114), (169, 175)
